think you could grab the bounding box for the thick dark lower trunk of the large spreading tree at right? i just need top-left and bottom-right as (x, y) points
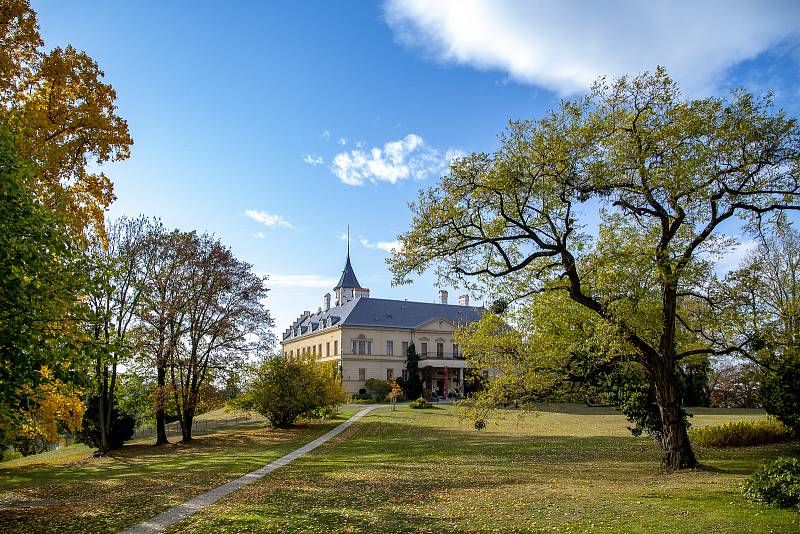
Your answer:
(656, 368), (697, 469)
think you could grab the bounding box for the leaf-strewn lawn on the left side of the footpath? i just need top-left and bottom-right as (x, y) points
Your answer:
(0, 410), (354, 533)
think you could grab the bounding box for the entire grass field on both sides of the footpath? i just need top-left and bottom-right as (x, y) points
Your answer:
(0, 405), (800, 533)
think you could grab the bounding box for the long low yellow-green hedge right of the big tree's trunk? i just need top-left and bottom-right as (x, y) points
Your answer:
(689, 417), (792, 447)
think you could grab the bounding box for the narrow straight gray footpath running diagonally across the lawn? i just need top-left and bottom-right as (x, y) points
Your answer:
(123, 404), (388, 534)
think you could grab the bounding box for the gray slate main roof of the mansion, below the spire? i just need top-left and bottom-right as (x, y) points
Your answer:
(283, 298), (485, 340)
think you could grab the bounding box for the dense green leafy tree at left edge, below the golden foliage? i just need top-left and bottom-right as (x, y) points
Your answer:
(0, 126), (90, 443)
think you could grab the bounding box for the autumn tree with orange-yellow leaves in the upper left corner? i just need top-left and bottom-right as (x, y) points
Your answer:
(0, 0), (133, 242)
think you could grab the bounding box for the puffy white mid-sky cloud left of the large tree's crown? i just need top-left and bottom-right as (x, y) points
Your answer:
(331, 133), (459, 185)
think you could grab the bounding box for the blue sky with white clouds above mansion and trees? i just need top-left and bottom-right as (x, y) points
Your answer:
(32, 0), (800, 338)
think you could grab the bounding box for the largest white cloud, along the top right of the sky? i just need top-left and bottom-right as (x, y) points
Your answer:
(385, 0), (800, 95)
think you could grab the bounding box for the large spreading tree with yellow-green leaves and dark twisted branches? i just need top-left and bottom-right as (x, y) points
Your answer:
(389, 69), (800, 469)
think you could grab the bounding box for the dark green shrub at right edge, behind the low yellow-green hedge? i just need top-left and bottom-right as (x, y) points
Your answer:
(758, 356), (800, 434)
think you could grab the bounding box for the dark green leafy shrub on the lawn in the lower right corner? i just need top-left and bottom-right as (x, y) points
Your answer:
(742, 458), (800, 508)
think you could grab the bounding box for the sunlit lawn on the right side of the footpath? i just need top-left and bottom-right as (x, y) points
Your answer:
(170, 405), (800, 533)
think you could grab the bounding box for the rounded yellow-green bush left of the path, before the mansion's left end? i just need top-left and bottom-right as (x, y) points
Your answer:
(232, 356), (347, 428)
